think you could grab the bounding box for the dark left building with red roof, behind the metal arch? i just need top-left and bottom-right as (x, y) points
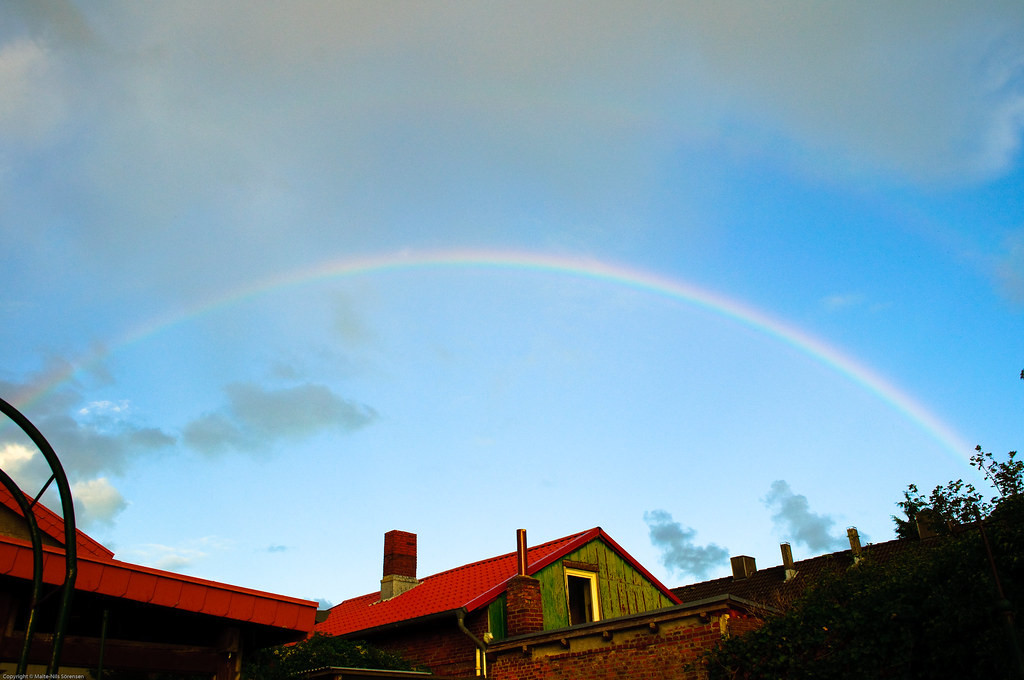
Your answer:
(0, 486), (316, 680)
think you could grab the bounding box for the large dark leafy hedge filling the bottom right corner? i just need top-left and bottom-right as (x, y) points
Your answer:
(706, 495), (1024, 680)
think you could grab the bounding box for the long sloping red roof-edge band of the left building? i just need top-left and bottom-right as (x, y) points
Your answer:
(0, 535), (316, 633)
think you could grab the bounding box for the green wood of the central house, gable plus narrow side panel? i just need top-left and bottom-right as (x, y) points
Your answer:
(487, 539), (674, 640)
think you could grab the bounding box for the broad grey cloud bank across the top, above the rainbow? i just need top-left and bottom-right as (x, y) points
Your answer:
(0, 0), (1024, 303)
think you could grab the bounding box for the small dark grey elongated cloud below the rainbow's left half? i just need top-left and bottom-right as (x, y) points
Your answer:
(182, 383), (377, 455)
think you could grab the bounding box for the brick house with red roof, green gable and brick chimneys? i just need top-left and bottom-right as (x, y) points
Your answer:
(315, 527), (760, 679)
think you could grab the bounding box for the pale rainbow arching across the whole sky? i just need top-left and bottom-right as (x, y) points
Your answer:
(8, 249), (972, 460)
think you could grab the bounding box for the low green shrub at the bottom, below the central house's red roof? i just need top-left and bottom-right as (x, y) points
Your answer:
(242, 633), (418, 680)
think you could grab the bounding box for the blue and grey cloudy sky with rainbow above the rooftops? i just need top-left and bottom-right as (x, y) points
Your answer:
(0, 0), (1024, 603)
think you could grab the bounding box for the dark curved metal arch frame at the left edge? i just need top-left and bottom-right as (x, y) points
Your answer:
(0, 398), (78, 676)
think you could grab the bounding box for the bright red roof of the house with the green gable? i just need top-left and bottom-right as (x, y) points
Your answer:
(316, 526), (678, 635)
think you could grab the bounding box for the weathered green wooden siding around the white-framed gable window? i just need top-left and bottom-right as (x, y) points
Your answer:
(532, 539), (672, 637)
